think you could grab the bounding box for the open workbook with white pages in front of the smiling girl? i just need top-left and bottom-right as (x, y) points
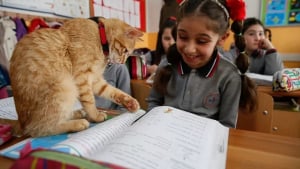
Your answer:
(0, 97), (229, 169)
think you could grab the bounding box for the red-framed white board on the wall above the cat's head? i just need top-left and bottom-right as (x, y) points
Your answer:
(91, 0), (146, 31)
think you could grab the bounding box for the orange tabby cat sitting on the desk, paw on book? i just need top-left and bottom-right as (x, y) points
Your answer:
(10, 18), (143, 137)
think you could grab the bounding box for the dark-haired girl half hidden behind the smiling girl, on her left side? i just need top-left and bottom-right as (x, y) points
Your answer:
(146, 16), (176, 75)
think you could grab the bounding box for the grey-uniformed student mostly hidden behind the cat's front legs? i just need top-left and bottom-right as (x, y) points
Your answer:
(95, 63), (131, 112)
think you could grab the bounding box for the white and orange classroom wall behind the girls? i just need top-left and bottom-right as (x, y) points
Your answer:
(137, 0), (300, 68)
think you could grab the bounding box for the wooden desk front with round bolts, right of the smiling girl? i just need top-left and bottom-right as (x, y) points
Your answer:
(237, 87), (300, 138)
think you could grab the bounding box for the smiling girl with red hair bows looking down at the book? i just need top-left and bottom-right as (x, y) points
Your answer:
(148, 0), (256, 127)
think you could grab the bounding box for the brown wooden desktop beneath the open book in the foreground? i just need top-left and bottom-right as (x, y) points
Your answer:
(0, 129), (300, 169)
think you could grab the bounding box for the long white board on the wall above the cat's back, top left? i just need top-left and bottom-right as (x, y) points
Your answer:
(0, 0), (90, 18)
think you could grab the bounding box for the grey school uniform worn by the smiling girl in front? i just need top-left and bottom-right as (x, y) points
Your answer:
(148, 51), (241, 127)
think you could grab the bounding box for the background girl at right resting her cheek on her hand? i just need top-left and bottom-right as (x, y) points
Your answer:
(230, 18), (284, 75)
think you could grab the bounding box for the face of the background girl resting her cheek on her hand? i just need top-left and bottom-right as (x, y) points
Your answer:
(243, 24), (265, 53)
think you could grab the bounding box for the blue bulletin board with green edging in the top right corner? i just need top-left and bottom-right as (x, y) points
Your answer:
(261, 0), (300, 27)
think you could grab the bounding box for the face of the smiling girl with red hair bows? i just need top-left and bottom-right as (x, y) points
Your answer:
(176, 16), (220, 69)
